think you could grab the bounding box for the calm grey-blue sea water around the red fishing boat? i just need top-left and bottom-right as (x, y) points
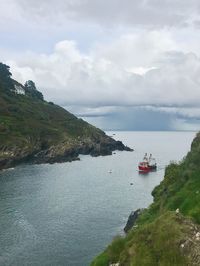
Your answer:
(0, 132), (195, 266)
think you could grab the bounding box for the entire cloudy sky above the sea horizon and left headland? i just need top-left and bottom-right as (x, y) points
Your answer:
(0, 0), (200, 130)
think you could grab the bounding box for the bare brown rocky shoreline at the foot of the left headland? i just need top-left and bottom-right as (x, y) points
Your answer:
(0, 137), (133, 170)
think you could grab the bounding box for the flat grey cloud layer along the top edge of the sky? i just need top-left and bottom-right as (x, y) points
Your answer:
(9, 0), (200, 27)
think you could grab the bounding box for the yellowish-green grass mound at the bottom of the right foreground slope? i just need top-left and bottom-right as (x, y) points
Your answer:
(91, 212), (189, 266)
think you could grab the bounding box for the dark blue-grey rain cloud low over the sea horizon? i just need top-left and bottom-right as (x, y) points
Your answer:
(80, 106), (200, 131)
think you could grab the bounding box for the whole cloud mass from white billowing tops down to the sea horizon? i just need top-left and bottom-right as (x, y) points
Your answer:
(4, 34), (200, 130)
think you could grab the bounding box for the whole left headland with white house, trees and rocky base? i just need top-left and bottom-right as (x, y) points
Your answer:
(0, 63), (130, 169)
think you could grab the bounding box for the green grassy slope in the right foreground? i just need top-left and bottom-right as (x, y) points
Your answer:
(91, 133), (200, 266)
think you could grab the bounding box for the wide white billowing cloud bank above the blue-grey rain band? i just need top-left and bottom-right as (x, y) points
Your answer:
(7, 35), (200, 106)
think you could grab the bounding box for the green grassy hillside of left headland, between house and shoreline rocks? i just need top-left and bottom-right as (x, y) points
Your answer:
(0, 85), (105, 156)
